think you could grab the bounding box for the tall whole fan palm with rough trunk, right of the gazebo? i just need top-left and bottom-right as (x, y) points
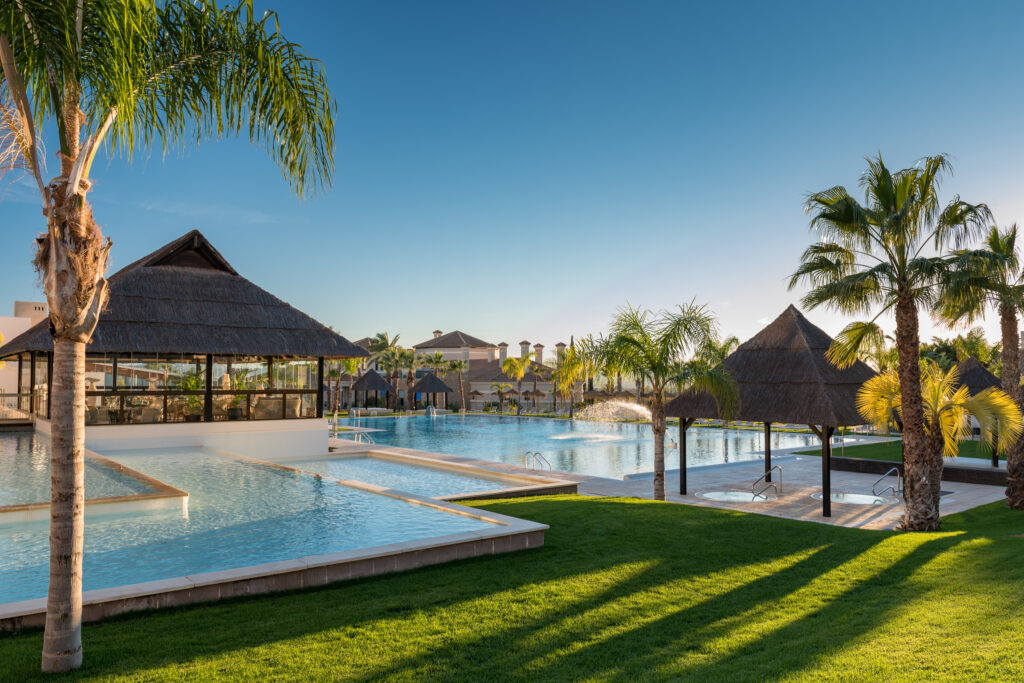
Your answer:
(790, 155), (990, 530)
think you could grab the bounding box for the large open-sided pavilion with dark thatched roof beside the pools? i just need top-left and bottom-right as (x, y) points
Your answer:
(0, 230), (367, 425)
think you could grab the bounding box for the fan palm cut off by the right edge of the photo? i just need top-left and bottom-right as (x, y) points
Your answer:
(936, 225), (1024, 510)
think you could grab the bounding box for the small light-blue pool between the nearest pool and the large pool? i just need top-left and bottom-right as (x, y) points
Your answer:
(285, 456), (509, 498)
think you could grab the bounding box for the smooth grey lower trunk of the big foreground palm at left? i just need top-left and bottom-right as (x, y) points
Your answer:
(42, 338), (85, 673)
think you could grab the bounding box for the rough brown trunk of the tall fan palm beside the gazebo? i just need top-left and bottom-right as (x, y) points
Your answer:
(896, 296), (941, 531)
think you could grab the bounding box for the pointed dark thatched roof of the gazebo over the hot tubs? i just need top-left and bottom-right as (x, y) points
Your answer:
(666, 305), (874, 427)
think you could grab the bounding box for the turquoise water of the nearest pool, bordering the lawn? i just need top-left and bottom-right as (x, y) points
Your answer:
(0, 449), (493, 603)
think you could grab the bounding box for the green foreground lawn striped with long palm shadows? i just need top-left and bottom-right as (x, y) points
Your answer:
(0, 496), (1024, 682)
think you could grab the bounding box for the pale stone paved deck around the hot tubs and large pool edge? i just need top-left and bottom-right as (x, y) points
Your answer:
(332, 438), (1005, 529)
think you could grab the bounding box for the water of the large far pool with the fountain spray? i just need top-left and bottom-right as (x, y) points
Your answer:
(339, 415), (819, 479)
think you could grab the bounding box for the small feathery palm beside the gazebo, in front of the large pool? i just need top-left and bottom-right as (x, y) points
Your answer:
(599, 302), (735, 501)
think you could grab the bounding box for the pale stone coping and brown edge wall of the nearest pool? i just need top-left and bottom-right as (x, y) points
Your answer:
(0, 475), (549, 631)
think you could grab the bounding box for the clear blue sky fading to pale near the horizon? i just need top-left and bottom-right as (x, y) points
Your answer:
(0, 0), (1024, 346)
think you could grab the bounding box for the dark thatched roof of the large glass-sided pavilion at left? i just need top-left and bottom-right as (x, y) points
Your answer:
(0, 230), (367, 358)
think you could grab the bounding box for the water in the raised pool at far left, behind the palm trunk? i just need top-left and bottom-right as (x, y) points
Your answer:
(0, 432), (153, 507)
